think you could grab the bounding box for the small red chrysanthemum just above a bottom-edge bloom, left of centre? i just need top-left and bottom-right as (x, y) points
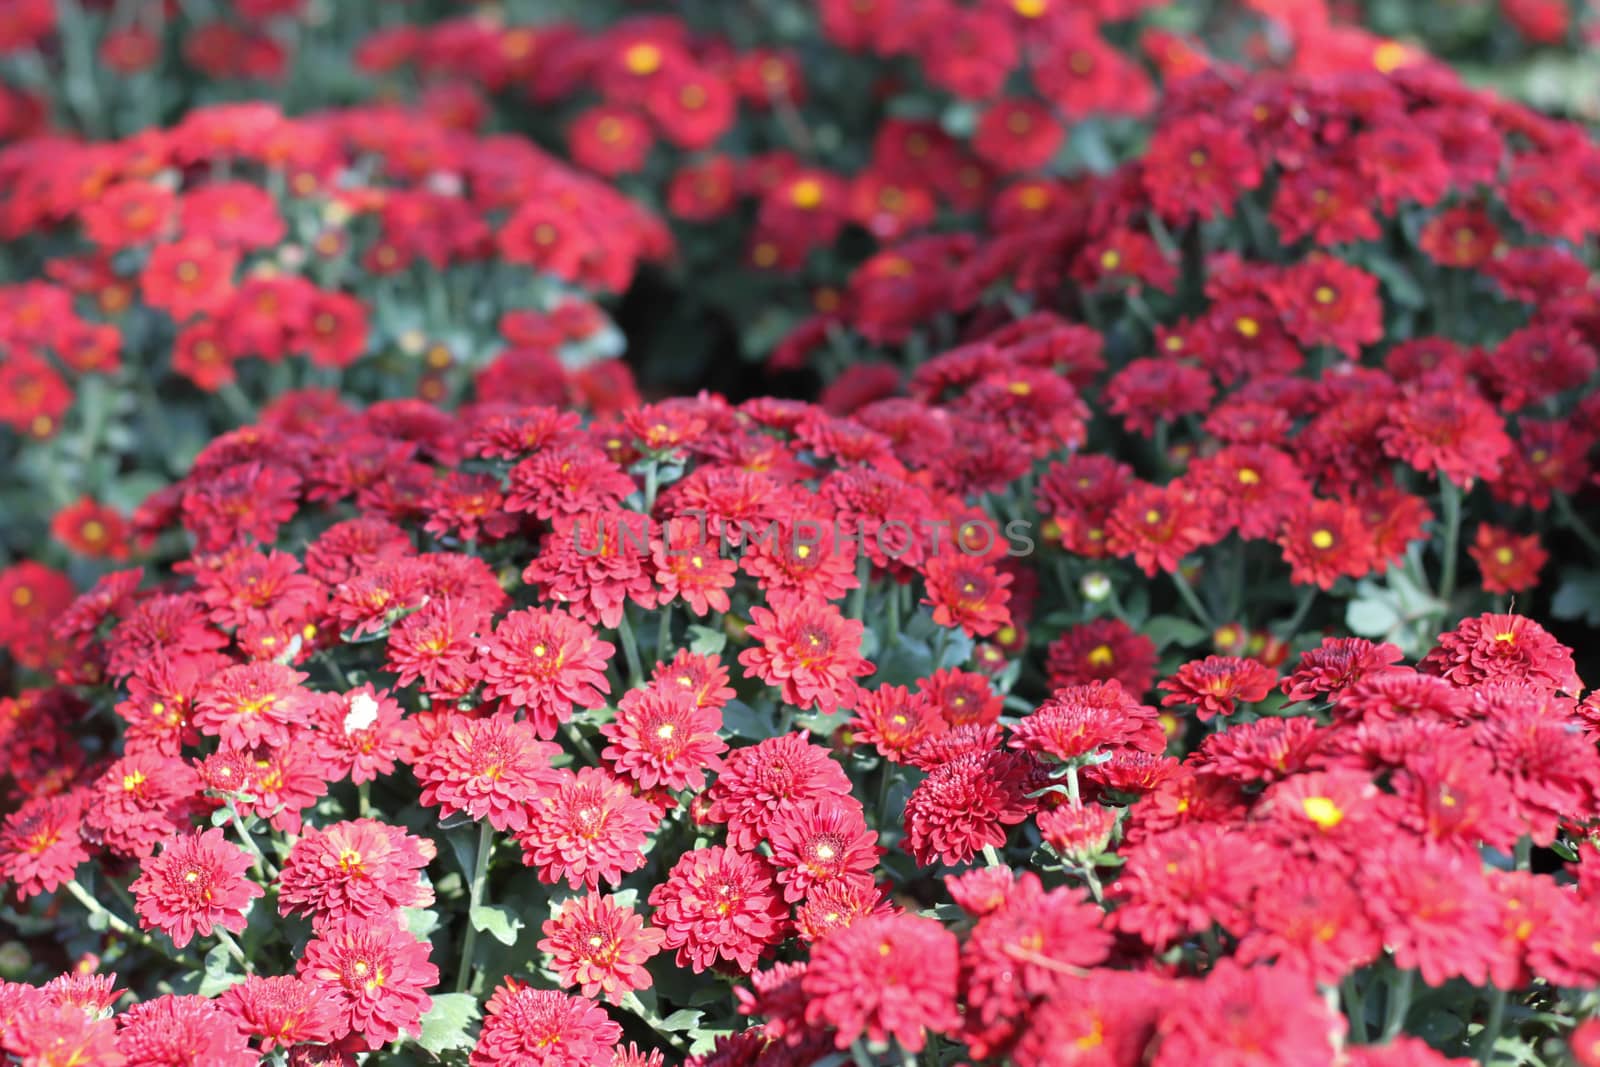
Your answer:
(539, 893), (666, 1003)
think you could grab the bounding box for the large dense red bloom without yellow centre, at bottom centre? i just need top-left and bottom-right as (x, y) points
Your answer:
(800, 915), (960, 1053)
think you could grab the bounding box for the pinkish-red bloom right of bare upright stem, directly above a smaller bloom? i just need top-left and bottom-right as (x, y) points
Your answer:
(517, 766), (658, 891)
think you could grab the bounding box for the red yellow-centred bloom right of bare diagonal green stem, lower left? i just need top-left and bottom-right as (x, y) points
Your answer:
(128, 827), (264, 949)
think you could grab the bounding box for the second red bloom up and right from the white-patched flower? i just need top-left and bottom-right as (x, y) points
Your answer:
(478, 608), (616, 737)
